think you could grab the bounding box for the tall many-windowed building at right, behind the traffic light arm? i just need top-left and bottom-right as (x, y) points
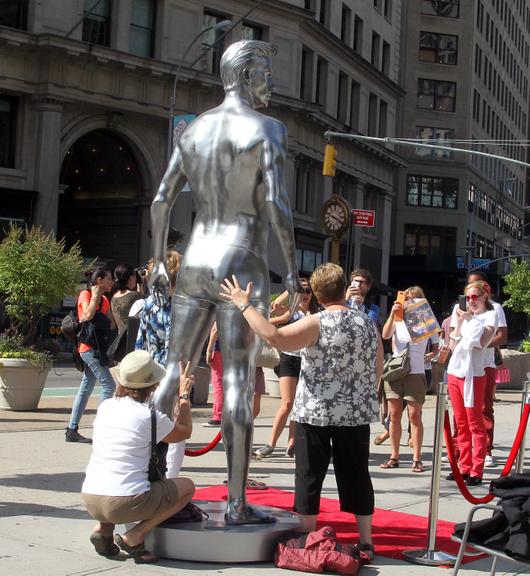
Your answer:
(390, 0), (530, 311)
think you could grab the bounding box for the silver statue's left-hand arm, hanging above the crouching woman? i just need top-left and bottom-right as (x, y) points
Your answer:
(149, 145), (186, 306)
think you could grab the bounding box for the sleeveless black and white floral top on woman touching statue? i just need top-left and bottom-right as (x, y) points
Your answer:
(293, 310), (379, 426)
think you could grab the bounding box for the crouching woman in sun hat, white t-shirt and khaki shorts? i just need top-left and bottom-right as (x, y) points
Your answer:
(81, 350), (195, 564)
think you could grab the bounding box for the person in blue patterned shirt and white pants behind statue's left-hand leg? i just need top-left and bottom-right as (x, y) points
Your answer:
(134, 250), (182, 478)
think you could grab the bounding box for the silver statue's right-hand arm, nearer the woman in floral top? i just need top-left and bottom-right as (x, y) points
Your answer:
(261, 123), (302, 307)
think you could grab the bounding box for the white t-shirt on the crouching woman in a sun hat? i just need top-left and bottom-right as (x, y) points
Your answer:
(81, 398), (174, 496)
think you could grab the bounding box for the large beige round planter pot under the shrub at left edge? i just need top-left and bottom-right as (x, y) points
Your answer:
(0, 358), (50, 410)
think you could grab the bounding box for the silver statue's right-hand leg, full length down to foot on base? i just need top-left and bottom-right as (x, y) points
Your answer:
(217, 304), (275, 524)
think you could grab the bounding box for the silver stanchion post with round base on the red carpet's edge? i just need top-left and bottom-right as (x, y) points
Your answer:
(403, 381), (456, 566)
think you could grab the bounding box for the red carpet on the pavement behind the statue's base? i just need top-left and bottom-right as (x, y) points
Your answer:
(194, 486), (470, 560)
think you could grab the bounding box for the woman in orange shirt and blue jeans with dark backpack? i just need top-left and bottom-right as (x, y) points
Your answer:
(65, 266), (116, 444)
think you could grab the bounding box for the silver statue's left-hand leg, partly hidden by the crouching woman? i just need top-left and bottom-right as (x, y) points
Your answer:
(153, 295), (215, 418)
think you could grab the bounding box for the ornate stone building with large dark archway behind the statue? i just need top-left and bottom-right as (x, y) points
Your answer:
(0, 0), (403, 290)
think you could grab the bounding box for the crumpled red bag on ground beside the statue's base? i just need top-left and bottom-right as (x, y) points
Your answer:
(274, 526), (361, 576)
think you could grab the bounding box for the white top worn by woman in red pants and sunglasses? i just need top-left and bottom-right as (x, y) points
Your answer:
(447, 310), (497, 378)
